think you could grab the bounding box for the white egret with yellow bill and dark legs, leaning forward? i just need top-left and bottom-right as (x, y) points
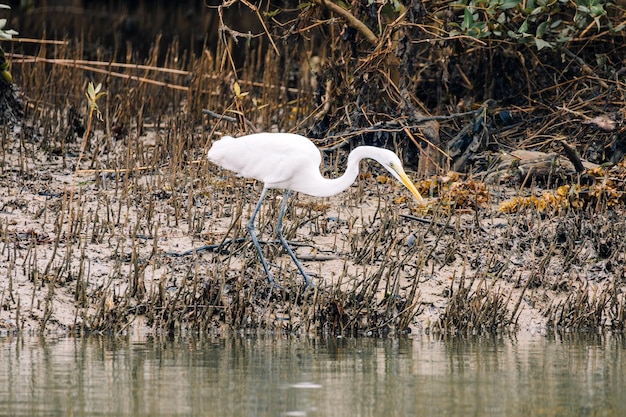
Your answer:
(207, 133), (422, 287)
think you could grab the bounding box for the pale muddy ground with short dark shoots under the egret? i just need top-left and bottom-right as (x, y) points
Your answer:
(0, 119), (626, 334)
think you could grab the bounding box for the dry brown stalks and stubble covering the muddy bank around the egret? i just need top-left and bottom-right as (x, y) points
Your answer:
(0, 2), (626, 335)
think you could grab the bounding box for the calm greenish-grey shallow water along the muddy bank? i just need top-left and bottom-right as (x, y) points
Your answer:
(0, 335), (626, 417)
